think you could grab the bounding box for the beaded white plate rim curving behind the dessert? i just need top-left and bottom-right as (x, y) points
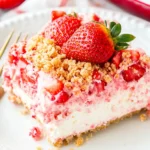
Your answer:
(0, 7), (150, 30)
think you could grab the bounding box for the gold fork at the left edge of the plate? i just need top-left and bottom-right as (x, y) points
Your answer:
(0, 30), (28, 99)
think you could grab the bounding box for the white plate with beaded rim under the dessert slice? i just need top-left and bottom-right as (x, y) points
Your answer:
(0, 8), (150, 150)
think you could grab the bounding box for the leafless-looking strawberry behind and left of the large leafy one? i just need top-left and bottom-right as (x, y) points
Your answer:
(42, 15), (81, 46)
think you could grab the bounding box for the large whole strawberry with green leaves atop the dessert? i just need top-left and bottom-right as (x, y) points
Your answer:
(61, 22), (135, 63)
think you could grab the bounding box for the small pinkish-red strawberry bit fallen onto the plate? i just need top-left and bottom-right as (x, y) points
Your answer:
(29, 127), (42, 141)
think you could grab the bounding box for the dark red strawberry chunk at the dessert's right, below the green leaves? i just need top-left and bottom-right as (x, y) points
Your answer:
(122, 64), (146, 82)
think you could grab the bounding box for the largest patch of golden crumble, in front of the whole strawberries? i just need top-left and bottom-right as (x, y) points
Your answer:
(25, 35), (122, 91)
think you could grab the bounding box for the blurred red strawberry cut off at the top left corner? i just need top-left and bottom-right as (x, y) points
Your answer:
(0, 0), (25, 9)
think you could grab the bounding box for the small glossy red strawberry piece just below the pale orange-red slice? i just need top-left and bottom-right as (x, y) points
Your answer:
(56, 91), (69, 104)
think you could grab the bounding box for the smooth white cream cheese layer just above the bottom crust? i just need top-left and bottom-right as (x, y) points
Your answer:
(13, 74), (150, 143)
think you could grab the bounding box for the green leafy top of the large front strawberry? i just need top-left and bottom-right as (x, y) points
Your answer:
(105, 21), (135, 50)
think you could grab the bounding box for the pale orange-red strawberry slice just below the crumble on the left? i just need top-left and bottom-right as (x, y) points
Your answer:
(45, 80), (64, 95)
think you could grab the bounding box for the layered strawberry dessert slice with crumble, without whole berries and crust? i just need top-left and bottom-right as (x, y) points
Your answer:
(3, 36), (150, 143)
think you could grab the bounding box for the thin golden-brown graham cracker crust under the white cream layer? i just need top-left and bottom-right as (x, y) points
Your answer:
(8, 93), (145, 147)
